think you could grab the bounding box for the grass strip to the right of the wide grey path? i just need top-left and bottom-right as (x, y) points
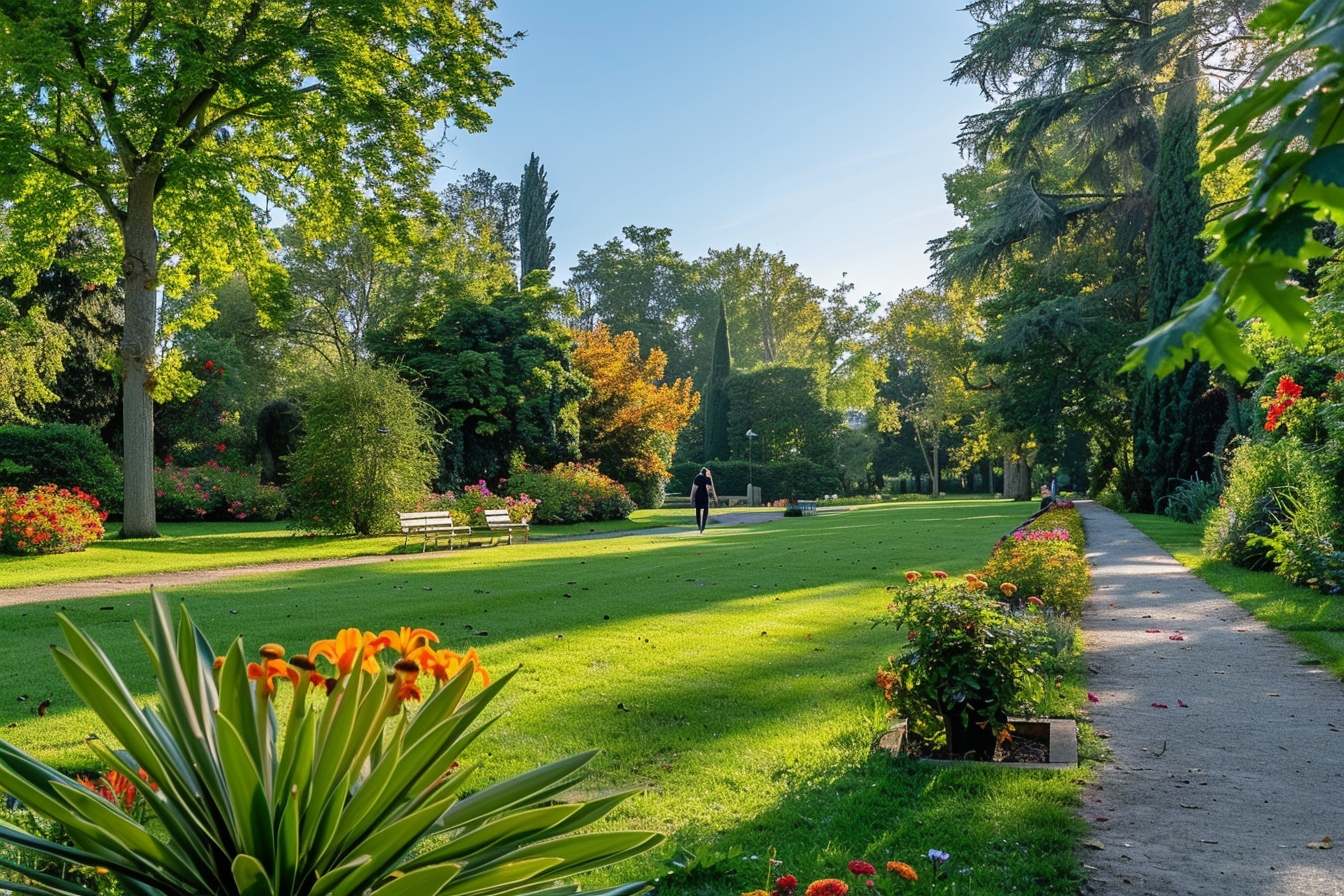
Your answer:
(1125, 513), (1344, 677)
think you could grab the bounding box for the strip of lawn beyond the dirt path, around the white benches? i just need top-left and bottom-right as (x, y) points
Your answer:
(0, 509), (694, 588)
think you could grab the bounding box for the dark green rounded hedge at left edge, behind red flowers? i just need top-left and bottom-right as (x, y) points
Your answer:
(0, 423), (122, 513)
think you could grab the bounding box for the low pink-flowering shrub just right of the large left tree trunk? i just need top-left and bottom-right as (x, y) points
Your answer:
(155, 458), (289, 523)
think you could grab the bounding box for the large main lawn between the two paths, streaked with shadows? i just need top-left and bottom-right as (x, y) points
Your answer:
(0, 500), (1083, 895)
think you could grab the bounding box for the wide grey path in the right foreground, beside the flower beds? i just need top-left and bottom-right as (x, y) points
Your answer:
(1078, 502), (1344, 896)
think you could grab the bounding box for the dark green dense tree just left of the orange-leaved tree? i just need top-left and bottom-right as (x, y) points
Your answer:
(374, 277), (587, 489)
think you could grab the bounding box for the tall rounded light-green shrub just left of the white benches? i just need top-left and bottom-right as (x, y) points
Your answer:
(286, 367), (438, 535)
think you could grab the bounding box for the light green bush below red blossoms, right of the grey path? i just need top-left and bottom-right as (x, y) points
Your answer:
(1204, 438), (1336, 570)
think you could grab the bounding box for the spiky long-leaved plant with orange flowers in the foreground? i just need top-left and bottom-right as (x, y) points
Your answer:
(0, 595), (663, 896)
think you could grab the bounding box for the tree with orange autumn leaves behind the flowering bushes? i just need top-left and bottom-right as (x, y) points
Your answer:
(574, 324), (700, 506)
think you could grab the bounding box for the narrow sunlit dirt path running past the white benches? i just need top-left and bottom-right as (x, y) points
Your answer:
(0, 512), (784, 607)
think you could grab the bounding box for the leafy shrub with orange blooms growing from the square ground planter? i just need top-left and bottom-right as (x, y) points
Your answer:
(879, 572), (1047, 760)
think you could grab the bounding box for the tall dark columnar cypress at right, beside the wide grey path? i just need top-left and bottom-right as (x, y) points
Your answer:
(1126, 54), (1212, 512)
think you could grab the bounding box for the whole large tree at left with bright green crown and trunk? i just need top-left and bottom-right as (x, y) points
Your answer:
(0, 0), (513, 537)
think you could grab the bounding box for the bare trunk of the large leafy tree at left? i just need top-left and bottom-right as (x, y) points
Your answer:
(121, 168), (159, 539)
